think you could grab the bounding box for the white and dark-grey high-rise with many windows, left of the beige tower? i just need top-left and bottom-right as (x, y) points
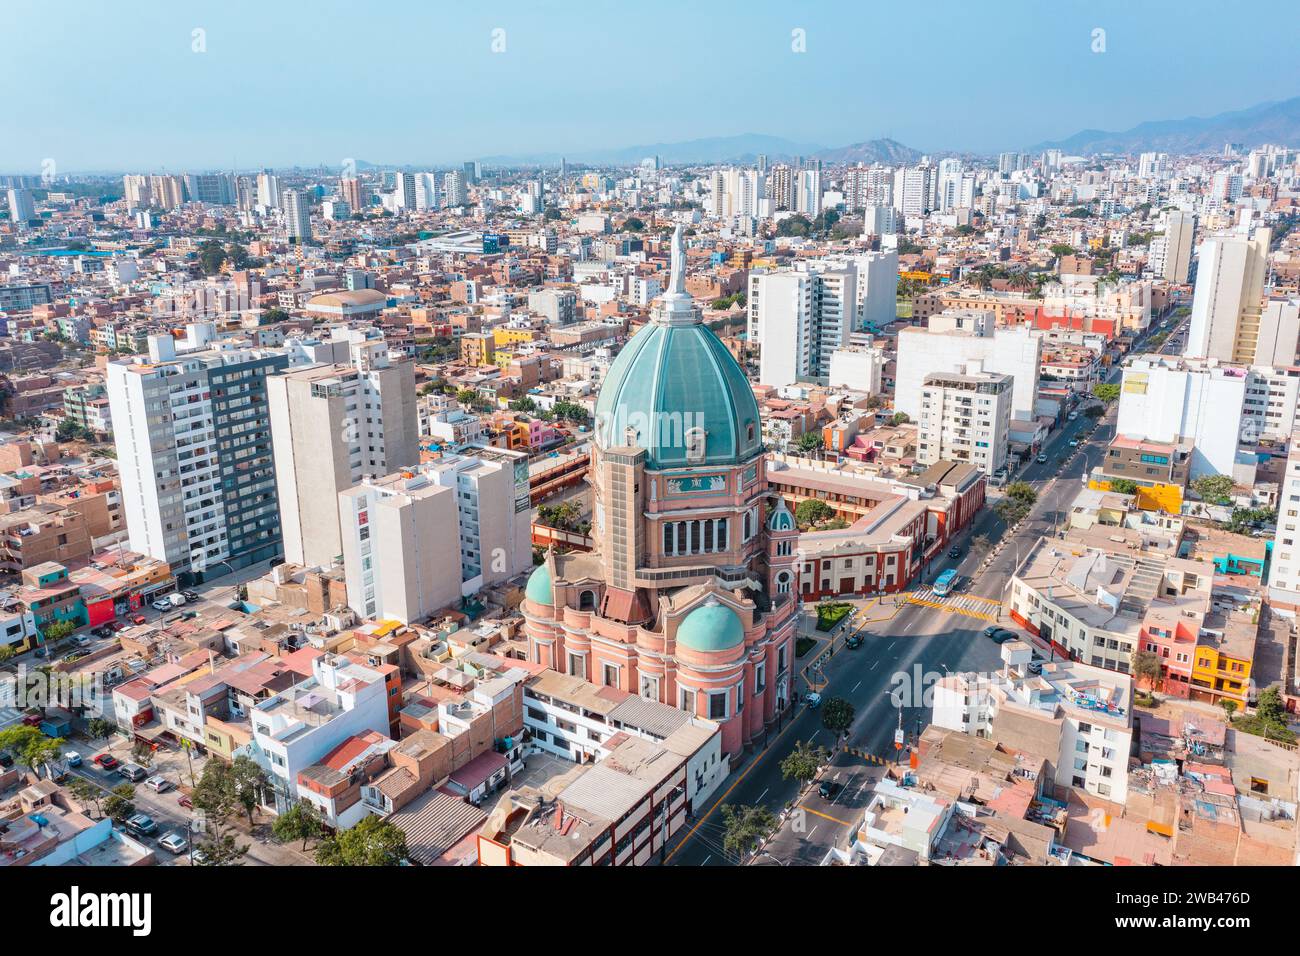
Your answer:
(107, 326), (289, 580)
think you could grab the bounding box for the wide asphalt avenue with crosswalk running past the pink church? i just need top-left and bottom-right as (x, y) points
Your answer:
(667, 316), (1173, 866)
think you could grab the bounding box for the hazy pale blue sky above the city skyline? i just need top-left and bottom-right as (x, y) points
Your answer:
(0, 0), (1300, 172)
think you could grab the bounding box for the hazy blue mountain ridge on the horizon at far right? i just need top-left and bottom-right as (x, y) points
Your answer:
(1030, 96), (1300, 156)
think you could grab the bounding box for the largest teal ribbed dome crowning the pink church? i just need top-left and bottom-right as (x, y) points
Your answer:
(595, 321), (762, 468)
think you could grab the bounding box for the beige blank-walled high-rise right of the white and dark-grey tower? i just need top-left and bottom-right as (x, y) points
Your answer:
(267, 332), (420, 567)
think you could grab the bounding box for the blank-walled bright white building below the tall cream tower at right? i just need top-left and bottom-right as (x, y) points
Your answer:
(1115, 355), (1248, 477)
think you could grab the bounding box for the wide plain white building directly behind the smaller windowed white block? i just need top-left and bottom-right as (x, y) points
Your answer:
(894, 310), (1043, 421)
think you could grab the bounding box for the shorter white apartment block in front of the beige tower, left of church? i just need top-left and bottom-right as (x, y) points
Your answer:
(338, 447), (532, 623)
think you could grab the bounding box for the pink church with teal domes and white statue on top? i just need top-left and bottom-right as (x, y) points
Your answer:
(523, 226), (800, 754)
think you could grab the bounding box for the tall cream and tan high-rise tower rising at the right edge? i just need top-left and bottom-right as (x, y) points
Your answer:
(1183, 229), (1271, 365)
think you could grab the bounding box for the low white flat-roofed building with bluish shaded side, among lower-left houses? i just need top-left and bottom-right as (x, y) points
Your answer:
(247, 654), (389, 813)
